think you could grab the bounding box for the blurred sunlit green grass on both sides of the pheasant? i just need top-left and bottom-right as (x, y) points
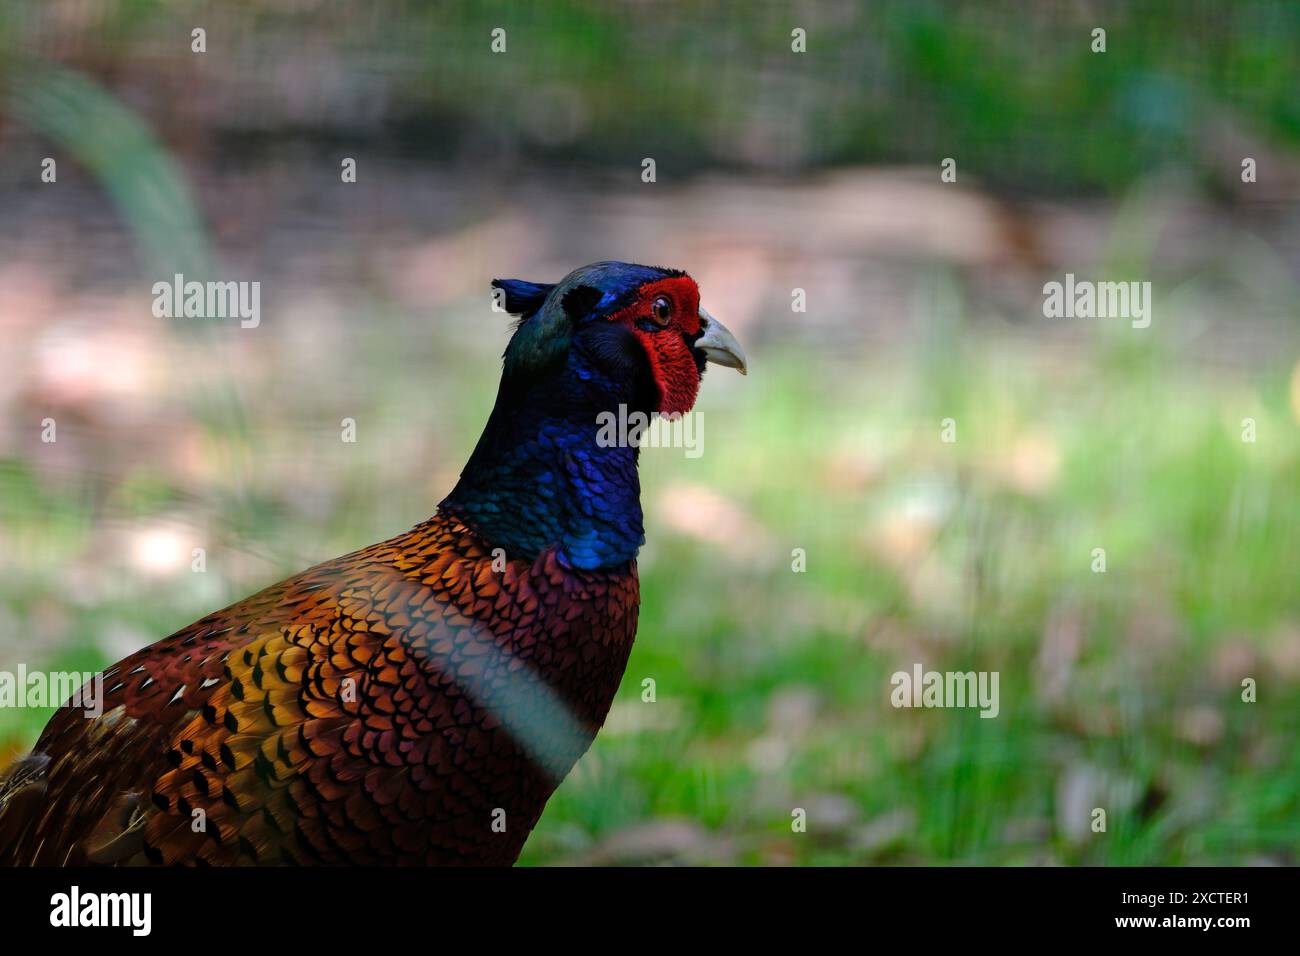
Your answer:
(0, 317), (1300, 865)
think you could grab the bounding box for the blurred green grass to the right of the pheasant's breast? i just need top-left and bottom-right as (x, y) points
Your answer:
(524, 338), (1300, 865)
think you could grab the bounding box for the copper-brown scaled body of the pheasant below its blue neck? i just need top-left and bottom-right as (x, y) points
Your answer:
(0, 515), (637, 865)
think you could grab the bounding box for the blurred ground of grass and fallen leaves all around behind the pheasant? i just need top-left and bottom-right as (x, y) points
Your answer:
(0, 155), (1300, 864)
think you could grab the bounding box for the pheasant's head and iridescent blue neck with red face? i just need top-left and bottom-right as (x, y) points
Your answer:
(442, 261), (746, 568)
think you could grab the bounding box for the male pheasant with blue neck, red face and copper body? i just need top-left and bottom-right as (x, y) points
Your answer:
(0, 261), (746, 865)
